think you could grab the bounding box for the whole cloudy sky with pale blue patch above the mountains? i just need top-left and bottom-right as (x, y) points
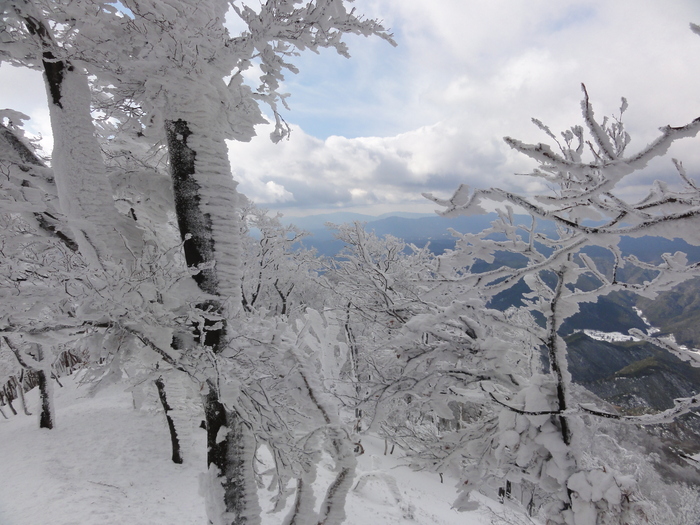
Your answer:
(0, 0), (700, 215)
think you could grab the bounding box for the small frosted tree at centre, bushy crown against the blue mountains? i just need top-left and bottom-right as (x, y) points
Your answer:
(320, 222), (436, 431)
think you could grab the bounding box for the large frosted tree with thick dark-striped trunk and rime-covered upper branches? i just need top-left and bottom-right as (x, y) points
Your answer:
(91, 1), (394, 523)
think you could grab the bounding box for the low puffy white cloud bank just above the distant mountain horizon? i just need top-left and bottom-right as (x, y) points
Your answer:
(230, 118), (525, 215)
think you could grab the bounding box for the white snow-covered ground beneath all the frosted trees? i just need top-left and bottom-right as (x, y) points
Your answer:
(0, 378), (536, 525)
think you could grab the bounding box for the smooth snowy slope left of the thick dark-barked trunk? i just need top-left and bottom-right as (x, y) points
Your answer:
(0, 380), (206, 525)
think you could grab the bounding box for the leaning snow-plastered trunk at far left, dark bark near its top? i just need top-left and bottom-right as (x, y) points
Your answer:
(0, 1), (141, 267)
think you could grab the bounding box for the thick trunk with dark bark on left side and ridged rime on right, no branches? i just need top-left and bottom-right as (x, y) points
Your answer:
(165, 115), (260, 525)
